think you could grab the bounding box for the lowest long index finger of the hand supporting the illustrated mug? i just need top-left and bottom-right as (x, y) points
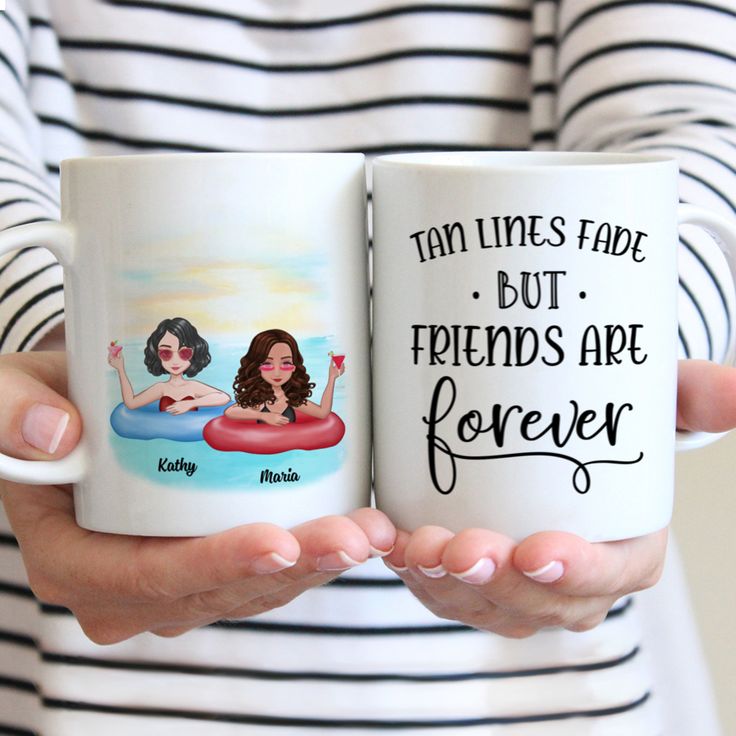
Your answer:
(4, 484), (300, 606)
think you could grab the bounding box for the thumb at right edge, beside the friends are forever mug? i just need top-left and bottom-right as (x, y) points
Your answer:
(677, 360), (736, 432)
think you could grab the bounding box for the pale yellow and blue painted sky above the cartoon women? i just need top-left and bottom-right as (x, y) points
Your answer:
(120, 230), (332, 339)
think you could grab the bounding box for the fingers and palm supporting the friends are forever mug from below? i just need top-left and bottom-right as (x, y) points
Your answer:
(384, 526), (667, 638)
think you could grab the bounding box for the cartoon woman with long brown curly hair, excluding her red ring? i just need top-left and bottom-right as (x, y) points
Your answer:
(225, 329), (345, 427)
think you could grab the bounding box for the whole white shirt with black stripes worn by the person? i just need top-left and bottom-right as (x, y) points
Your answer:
(0, 0), (736, 736)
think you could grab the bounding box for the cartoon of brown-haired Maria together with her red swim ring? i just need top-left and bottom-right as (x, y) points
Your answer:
(204, 329), (345, 454)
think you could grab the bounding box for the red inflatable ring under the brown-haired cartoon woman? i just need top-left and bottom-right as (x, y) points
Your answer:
(202, 409), (345, 455)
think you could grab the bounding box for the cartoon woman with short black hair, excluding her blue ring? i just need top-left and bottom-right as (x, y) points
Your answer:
(107, 317), (230, 414)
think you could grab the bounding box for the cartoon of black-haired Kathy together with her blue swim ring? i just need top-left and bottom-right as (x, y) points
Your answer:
(107, 317), (230, 441)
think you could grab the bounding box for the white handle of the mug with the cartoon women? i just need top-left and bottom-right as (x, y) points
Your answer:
(0, 221), (87, 485)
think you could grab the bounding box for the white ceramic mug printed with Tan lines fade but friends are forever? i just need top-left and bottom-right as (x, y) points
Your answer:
(373, 153), (736, 541)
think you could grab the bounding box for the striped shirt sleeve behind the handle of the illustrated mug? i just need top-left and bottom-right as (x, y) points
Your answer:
(0, 0), (63, 353)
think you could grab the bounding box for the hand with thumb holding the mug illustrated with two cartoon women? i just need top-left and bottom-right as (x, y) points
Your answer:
(0, 352), (396, 644)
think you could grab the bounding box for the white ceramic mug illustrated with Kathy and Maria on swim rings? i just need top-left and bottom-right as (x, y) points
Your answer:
(0, 154), (371, 536)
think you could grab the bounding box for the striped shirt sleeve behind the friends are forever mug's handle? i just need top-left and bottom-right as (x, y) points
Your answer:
(548, 0), (736, 360)
